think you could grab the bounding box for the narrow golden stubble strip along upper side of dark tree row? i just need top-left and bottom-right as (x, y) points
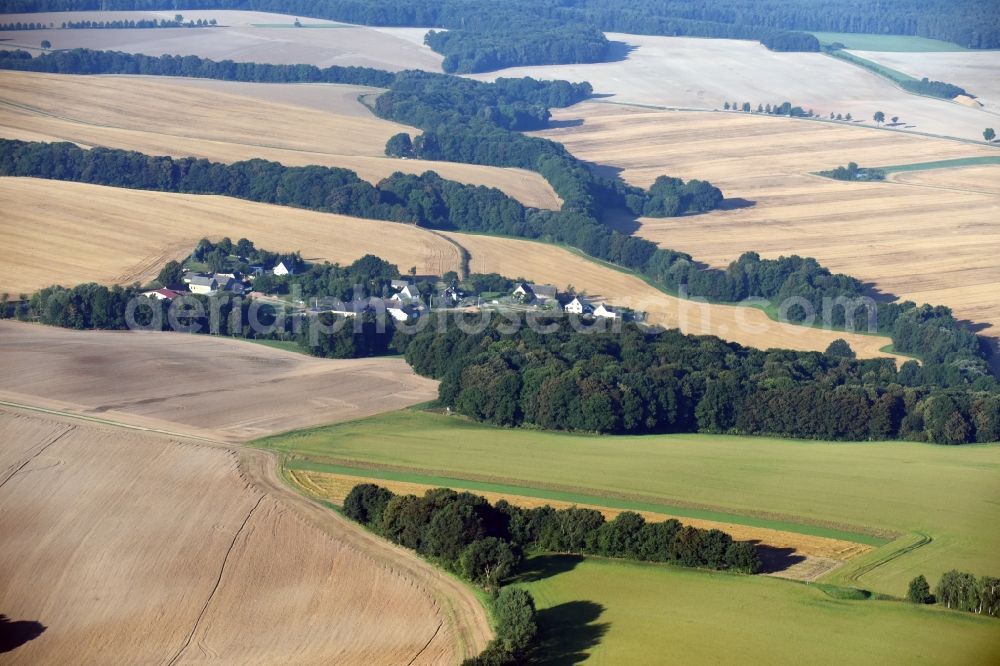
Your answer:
(287, 469), (872, 580)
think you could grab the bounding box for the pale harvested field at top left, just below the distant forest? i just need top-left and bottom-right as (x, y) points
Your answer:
(0, 9), (443, 72)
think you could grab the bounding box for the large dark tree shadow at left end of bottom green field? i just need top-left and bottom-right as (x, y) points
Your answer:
(528, 601), (610, 666)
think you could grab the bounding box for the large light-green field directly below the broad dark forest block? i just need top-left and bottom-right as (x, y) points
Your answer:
(258, 410), (1000, 596)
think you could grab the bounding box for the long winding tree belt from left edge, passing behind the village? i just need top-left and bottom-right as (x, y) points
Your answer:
(0, 134), (990, 386)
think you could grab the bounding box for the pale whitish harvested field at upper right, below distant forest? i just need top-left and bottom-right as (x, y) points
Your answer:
(475, 33), (996, 140)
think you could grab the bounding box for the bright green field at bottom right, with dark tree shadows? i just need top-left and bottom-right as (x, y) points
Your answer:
(519, 556), (1000, 666)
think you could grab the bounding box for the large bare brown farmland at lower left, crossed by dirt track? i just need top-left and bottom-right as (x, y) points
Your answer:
(0, 322), (490, 664)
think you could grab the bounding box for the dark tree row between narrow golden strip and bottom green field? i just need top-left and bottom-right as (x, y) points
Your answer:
(344, 484), (761, 589)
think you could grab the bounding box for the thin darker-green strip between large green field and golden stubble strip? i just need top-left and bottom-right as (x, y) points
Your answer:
(285, 459), (890, 546)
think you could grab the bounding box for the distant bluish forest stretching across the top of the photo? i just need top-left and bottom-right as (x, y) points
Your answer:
(5, 0), (1000, 62)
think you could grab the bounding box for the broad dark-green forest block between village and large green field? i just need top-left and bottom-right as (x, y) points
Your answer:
(404, 314), (1000, 444)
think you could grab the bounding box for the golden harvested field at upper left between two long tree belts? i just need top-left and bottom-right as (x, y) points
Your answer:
(0, 71), (560, 209)
